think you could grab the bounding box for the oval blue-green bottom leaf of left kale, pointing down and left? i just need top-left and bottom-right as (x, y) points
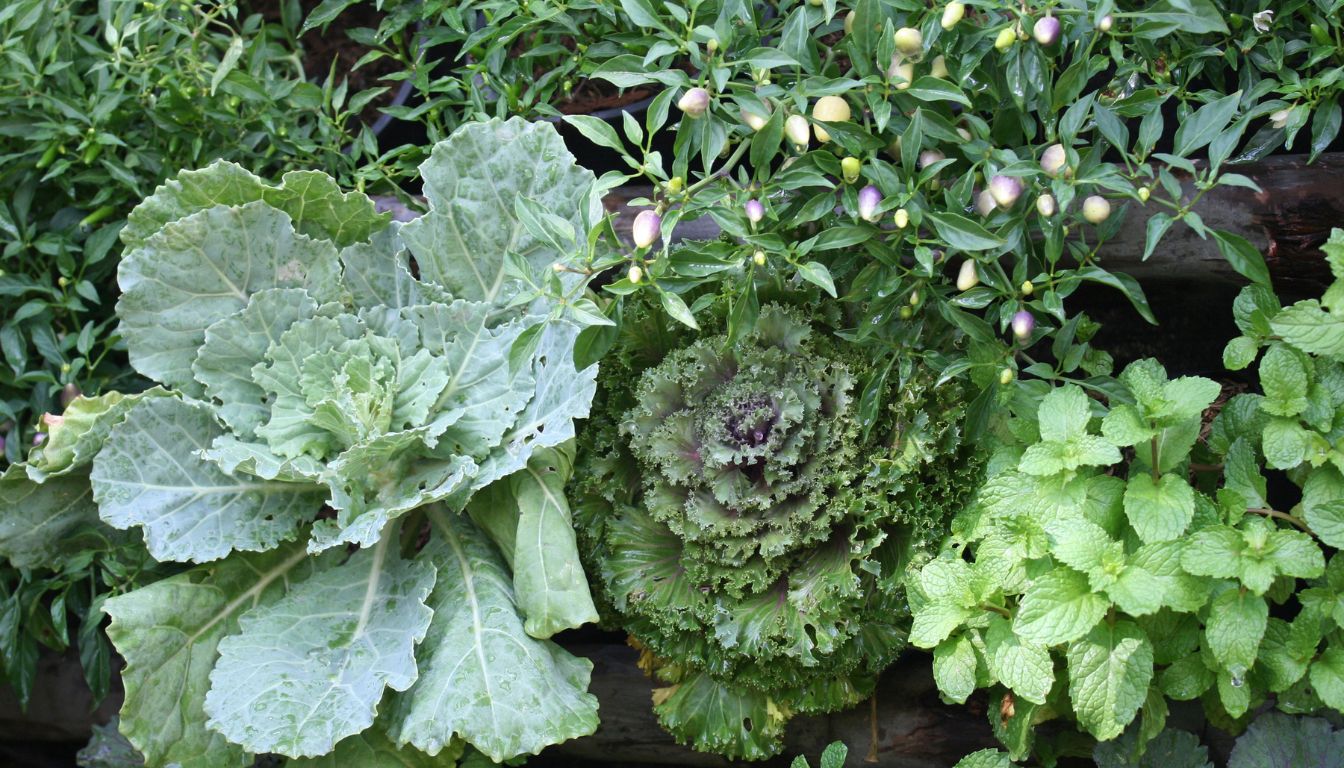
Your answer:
(206, 535), (434, 757)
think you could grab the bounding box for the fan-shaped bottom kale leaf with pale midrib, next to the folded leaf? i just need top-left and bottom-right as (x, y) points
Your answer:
(390, 508), (598, 761)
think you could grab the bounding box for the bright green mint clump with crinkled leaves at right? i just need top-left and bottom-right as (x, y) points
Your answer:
(910, 230), (1344, 759)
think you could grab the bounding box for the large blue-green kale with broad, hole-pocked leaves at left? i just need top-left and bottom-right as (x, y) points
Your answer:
(3, 120), (601, 768)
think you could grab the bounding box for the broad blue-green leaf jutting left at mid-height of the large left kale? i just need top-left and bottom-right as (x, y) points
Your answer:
(91, 398), (324, 562)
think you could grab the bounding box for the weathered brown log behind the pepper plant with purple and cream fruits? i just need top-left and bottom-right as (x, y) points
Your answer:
(606, 153), (1344, 295)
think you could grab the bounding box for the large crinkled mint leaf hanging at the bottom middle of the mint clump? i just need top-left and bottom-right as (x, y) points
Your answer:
(1064, 620), (1153, 741)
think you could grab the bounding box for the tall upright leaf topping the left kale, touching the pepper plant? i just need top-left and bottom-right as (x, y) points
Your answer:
(402, 117), (601, 301)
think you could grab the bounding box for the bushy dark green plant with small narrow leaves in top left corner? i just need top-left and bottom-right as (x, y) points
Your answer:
(0, 0), (382, 464)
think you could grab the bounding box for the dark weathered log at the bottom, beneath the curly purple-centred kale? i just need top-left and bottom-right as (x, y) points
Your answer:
(544, 644), (995, 768)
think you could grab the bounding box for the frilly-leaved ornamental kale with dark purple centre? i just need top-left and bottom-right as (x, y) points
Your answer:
(575, 304), (978, 759)
